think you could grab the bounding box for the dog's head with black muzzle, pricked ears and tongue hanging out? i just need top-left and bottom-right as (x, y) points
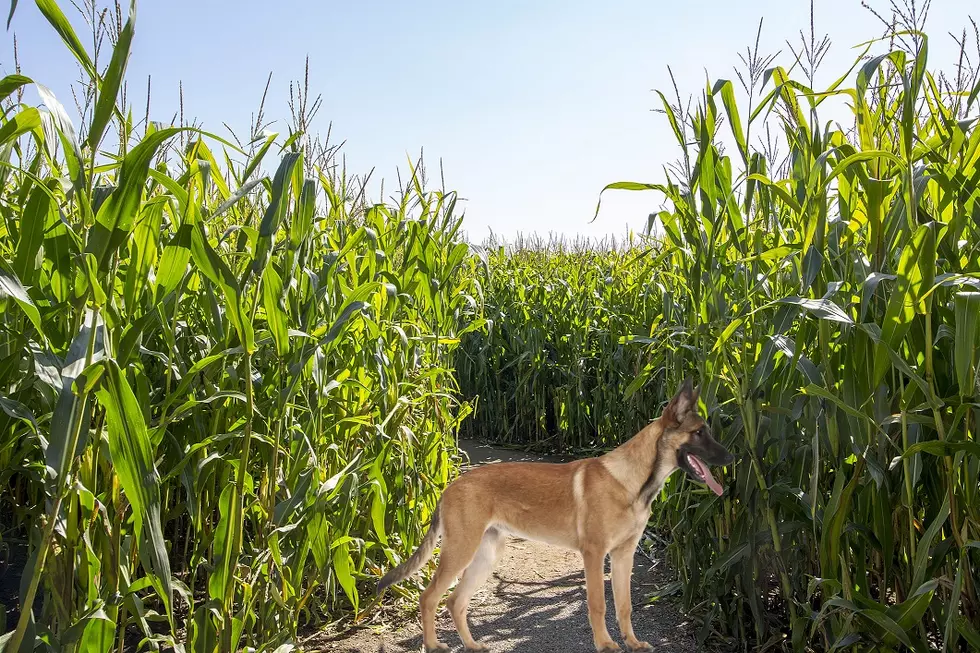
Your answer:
(658, 379), (735, 496)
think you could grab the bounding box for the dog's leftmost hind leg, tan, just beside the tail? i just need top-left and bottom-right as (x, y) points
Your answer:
(419, 521), (483, 653)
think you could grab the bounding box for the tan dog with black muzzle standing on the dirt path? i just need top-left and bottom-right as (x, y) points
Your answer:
(378, 381), (734, 653)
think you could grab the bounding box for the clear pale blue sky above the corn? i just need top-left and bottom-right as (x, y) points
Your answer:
(0, 0), (968, 240)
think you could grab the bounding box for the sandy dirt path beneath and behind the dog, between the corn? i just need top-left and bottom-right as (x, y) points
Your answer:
(305, 442), (698, 653)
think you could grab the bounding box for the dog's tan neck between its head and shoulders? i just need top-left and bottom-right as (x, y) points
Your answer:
(602, 419), (677, 504)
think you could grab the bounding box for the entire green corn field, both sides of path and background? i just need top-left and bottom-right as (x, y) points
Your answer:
(0, 0), (980, 653)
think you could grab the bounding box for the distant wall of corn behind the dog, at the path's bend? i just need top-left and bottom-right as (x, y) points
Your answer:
(456, 237), (669, 451)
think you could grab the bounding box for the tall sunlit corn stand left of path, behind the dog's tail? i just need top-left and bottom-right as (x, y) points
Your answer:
(0, 0), (481, 652)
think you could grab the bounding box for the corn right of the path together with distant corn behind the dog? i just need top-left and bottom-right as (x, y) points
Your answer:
(457, 5), (980, 651)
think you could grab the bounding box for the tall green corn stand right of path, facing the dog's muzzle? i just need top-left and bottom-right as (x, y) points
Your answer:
(592, 10), (980, 651)
